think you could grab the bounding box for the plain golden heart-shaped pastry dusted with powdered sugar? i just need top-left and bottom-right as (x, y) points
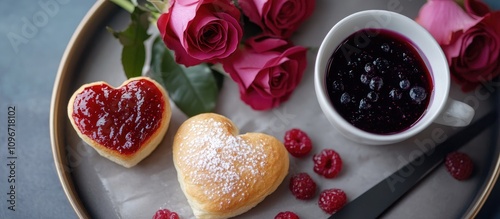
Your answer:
(173, 113), (289, 219)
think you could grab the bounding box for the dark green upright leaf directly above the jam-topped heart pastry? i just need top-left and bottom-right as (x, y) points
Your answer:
(107, 7), (150, 78)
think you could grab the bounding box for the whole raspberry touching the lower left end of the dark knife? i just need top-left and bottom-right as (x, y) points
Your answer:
(318, 189), (347, 214)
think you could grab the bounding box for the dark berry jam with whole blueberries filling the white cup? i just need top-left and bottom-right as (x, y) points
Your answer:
(326, 29), (433, 134)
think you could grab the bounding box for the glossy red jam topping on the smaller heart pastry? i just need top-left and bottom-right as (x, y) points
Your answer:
(73, 79), (165, 154)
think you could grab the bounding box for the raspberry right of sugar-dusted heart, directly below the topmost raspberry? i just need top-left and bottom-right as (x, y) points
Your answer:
(289, 173), (316, 200)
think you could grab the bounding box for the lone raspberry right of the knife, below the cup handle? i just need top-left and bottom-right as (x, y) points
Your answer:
(445, 152), (474, 180)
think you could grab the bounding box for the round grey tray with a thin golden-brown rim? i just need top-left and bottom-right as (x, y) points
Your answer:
(50, 0), (500, 218)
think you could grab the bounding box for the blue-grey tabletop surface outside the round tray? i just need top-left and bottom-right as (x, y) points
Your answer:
(0, 0), (500, 218)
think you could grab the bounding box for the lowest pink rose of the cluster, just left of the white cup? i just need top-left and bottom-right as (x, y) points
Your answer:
(223, 35), (307, 110)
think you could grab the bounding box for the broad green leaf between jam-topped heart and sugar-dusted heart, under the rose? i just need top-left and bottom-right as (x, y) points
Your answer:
(150, 38), (219, 117)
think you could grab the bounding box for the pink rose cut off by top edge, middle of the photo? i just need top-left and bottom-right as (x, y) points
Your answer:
(238, 0), (316, 38)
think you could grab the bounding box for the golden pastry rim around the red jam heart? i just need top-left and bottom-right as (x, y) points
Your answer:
(68, 77), (172, 168)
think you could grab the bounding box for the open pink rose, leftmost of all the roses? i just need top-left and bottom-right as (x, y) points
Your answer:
(157, 0), (243, 66)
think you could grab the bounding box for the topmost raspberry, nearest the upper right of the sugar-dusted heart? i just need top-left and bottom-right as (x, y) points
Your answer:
(285, 129), (312, 157)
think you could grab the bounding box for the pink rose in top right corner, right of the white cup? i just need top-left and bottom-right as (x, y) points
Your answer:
(416, 0), (500, 91)
